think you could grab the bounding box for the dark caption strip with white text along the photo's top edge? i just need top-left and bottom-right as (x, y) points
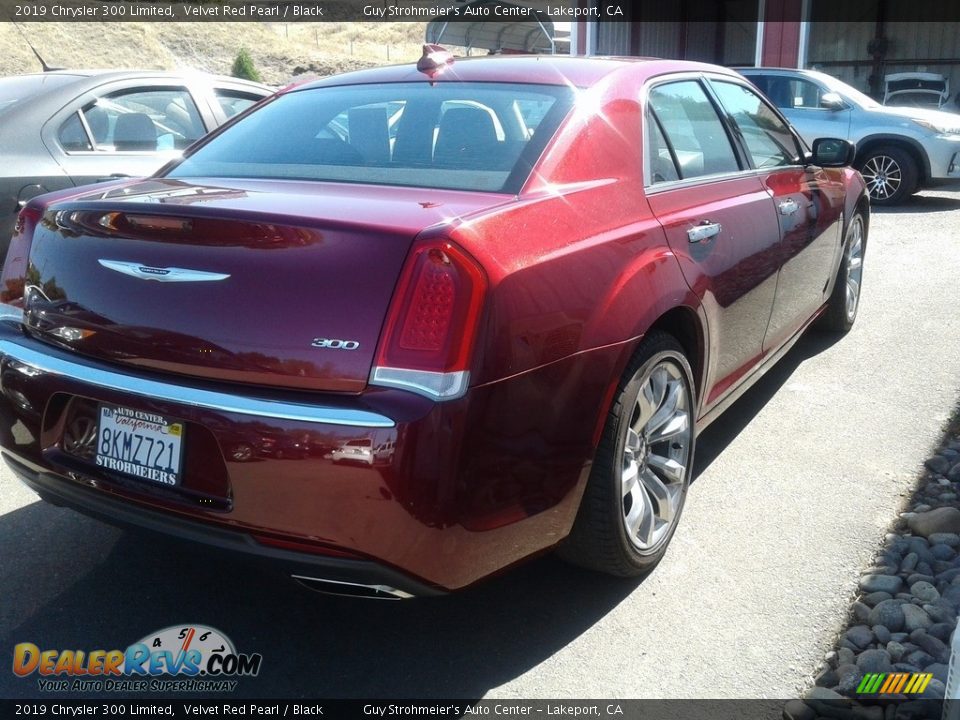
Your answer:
(0, 0), (960, 23)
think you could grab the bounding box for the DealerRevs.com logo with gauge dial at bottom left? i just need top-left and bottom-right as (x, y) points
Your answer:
(13, 625), (263, 692)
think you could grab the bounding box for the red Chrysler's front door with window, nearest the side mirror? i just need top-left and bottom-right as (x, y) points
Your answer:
(710, 77), (844, 351)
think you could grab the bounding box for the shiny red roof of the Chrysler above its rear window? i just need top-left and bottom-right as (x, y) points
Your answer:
(291, 55), (735, 91)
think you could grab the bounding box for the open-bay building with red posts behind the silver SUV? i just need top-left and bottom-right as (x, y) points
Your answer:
(570, 0), (960, 98)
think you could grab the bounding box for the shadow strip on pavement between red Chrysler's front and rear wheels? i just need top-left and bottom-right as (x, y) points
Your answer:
(692, 328), (842, 482)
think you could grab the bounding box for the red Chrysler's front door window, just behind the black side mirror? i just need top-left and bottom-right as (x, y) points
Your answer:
(712, 81), (799, 168)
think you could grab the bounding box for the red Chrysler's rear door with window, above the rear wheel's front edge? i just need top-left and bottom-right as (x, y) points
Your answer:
(645, 75), (780, 411)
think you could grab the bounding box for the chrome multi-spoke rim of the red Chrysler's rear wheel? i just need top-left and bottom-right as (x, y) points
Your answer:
(620, 359), (693, 554)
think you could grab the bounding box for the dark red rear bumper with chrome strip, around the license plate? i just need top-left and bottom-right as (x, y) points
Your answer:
(0, 307), (620, 595)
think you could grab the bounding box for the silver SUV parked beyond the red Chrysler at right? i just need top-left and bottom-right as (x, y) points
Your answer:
(738, 68), (960, 205)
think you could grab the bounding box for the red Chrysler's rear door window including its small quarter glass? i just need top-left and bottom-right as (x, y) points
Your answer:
(648, 80), (740, 179)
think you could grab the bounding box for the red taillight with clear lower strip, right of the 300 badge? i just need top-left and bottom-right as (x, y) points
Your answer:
(370, 241), (487, 400)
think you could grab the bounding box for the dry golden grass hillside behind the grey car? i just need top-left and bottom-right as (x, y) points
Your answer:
(0, 22), (425, 85)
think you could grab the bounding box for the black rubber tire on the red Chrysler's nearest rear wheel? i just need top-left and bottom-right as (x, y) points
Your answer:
(558, 331), (696, 577)
